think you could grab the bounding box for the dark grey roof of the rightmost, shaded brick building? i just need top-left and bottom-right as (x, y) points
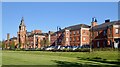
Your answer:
(92, 20), (120, 30)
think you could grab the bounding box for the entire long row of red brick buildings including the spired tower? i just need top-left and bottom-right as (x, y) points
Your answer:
(5, 18), (120, 48)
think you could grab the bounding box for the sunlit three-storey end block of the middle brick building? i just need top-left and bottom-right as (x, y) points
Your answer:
(67, 24), (90, 46)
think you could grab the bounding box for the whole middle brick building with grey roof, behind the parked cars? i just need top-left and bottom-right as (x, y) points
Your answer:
(48, 24), (90, 46)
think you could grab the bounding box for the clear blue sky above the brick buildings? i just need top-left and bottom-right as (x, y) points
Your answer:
(2, 2), (118, 39)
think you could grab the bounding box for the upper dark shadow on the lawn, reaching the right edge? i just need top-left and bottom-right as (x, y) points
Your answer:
(77, 57), (120, 67)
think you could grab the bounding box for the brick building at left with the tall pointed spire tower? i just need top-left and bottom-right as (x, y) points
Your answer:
(5, 17), (46, 48)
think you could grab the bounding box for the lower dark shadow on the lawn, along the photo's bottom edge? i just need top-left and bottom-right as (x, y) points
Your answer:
(52, 60), (117, 67)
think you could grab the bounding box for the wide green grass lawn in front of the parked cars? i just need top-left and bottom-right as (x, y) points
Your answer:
(2, 51), (120, 67)
